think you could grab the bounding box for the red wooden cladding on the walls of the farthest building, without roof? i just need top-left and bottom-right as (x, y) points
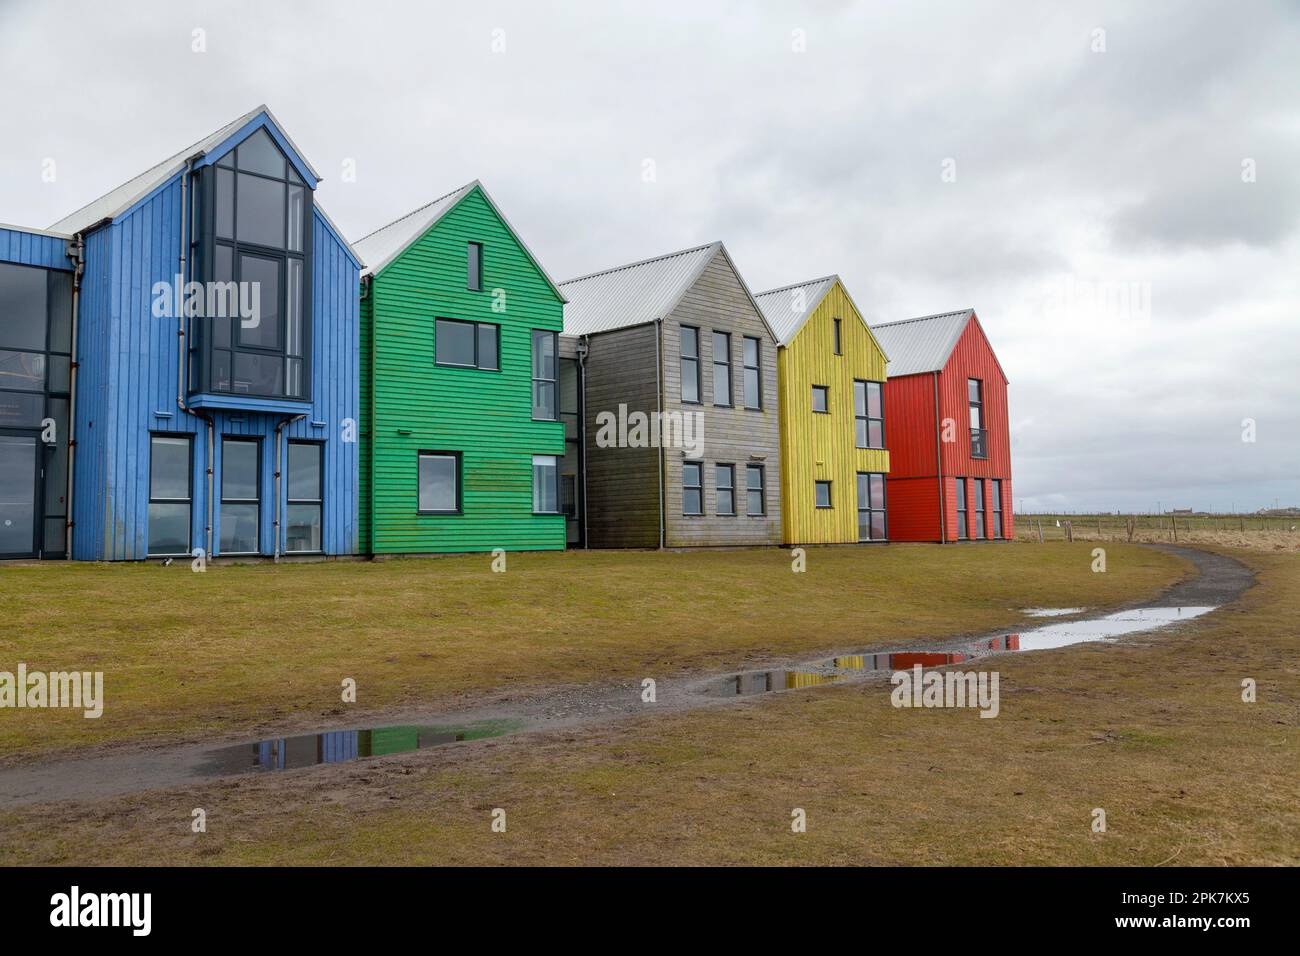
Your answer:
(885, 315), (1015, 541)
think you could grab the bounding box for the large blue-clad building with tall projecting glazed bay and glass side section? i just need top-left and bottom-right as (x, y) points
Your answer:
(0, 107), (361, 561)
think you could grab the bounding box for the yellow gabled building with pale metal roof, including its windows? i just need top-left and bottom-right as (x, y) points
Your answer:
(754, 276), (889, 545)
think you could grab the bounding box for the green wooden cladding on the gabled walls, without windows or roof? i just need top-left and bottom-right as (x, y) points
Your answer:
(360, 186), (566, 554)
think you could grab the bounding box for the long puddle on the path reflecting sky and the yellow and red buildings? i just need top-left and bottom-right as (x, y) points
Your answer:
(702, 607), (1214, 696)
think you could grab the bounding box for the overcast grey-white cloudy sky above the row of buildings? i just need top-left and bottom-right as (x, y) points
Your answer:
(0, 0), (1300, 510)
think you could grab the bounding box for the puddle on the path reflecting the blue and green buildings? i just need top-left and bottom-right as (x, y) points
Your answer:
(199, 721), (523, 777)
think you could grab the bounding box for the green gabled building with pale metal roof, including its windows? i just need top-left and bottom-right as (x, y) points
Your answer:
(353, 181), (573, 554)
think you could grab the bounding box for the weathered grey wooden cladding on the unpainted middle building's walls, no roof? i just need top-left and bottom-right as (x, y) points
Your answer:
(572, 247), (781, 548)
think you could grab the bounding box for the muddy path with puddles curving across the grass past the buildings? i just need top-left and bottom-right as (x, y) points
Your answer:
(0, 545), (1255, 806)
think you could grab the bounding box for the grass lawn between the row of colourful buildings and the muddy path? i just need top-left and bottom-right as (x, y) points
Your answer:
(0, 544), (1187, 761)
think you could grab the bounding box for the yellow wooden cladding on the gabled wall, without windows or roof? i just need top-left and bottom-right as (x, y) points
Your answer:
(776, 281), (889, 545)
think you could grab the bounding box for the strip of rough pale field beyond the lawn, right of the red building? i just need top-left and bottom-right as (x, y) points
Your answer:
(1015, 514), (1300, 551)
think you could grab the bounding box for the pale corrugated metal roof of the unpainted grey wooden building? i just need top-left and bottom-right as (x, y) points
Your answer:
(560, 242), (723, 336)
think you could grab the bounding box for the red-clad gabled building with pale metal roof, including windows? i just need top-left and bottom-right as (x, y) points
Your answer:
(871, 308), (1014, 541)
